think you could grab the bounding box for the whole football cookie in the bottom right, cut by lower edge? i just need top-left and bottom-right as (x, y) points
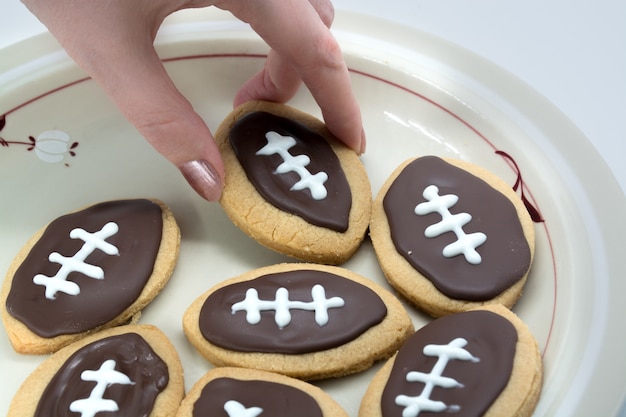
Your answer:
(359, 305), (543, 417)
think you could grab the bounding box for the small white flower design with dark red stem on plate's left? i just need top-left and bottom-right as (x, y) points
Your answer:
(0, 116), (78, 165)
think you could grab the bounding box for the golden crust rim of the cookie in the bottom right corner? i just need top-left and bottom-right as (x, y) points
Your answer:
(359, 304), (543, 417)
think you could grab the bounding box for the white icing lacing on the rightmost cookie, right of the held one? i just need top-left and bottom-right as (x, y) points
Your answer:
(415, 185), (487, 265)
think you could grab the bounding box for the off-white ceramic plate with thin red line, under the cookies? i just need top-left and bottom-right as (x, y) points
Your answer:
(0, 11), (626, 416)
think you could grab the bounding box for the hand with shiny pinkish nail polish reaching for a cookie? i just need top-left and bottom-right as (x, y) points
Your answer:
(23, 0), (365, 201)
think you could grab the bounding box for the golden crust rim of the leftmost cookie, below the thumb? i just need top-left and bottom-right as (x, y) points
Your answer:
(0, 199), (180, 355)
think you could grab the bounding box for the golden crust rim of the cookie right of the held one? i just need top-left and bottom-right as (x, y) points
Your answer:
(370, 158), (535, 317)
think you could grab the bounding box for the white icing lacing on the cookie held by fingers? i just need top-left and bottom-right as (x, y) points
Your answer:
(256, 131), (328, 200)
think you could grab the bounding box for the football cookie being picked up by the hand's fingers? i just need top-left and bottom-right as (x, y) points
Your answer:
(215, 101), (372, 265)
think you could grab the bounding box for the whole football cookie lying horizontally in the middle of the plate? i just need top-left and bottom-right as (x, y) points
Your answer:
(183, 264), (413, 380)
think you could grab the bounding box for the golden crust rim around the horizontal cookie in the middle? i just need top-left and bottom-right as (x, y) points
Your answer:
(183, 264), (414, 380)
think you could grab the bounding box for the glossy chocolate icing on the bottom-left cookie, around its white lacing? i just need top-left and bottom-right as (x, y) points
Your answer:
(34, 333), (169, 417)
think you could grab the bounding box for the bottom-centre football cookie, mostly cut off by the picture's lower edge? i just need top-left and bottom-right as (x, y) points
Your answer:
(175, 367), (348, 417)
